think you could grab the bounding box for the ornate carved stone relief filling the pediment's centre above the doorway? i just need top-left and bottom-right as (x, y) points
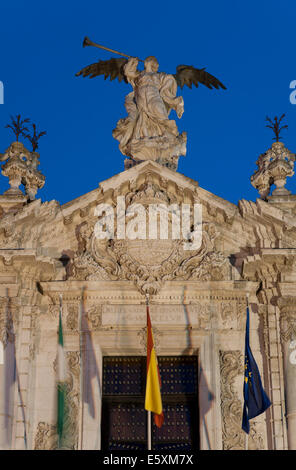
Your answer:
(69, 162), (229, 294)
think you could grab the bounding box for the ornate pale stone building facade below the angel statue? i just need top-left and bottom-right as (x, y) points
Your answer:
(0, 140), (296, 450)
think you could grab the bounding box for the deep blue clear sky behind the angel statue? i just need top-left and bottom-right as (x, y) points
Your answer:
(0, 0), (296, 204)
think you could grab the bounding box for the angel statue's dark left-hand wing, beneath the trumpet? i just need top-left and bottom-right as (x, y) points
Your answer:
(76, 58), (127, 83)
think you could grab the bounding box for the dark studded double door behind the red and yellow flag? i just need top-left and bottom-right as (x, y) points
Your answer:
(102, 356), (199, 451)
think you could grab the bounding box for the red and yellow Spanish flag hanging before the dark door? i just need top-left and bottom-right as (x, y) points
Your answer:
(145, 305), (164, 428)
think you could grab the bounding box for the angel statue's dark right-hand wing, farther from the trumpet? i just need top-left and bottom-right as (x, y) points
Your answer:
(174, 65), (226, 90)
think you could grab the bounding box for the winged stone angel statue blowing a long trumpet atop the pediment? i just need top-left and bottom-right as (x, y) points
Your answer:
(76, 38), (225, 170)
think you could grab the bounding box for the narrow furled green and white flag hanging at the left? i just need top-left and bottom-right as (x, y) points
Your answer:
(57, 300), (67, 448)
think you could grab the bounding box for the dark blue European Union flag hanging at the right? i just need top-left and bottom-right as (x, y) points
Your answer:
(242, 307), (271, 434)
